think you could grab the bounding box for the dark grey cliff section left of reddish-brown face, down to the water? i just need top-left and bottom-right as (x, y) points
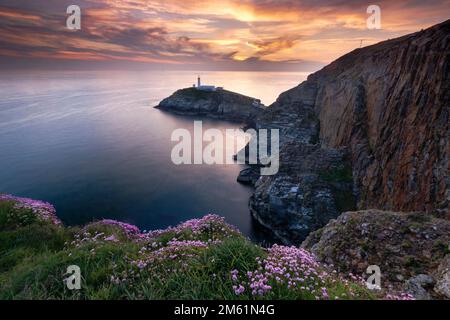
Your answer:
(249, 81), (355, 244)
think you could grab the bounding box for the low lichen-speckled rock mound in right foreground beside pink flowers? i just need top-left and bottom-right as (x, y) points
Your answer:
(302, 210), (450, 299)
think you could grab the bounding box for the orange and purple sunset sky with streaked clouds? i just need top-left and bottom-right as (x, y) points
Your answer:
(0, 0), (450, 71)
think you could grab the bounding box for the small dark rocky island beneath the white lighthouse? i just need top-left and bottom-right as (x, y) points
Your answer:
(156, 88), (264, 123)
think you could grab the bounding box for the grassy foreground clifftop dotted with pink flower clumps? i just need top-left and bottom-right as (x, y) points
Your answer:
(0, 195), (404, 299)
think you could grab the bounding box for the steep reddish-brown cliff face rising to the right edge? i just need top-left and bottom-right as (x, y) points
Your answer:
(264, 20), (450, 214)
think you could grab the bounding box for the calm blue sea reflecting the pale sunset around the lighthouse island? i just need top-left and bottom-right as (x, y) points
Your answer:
(0, 72), (306, 238)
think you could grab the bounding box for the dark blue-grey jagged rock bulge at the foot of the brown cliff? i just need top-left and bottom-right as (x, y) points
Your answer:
(249, 141), (355, 244)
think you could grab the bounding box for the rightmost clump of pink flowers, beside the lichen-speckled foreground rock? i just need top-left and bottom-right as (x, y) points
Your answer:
(231, 245), (370, 300)
